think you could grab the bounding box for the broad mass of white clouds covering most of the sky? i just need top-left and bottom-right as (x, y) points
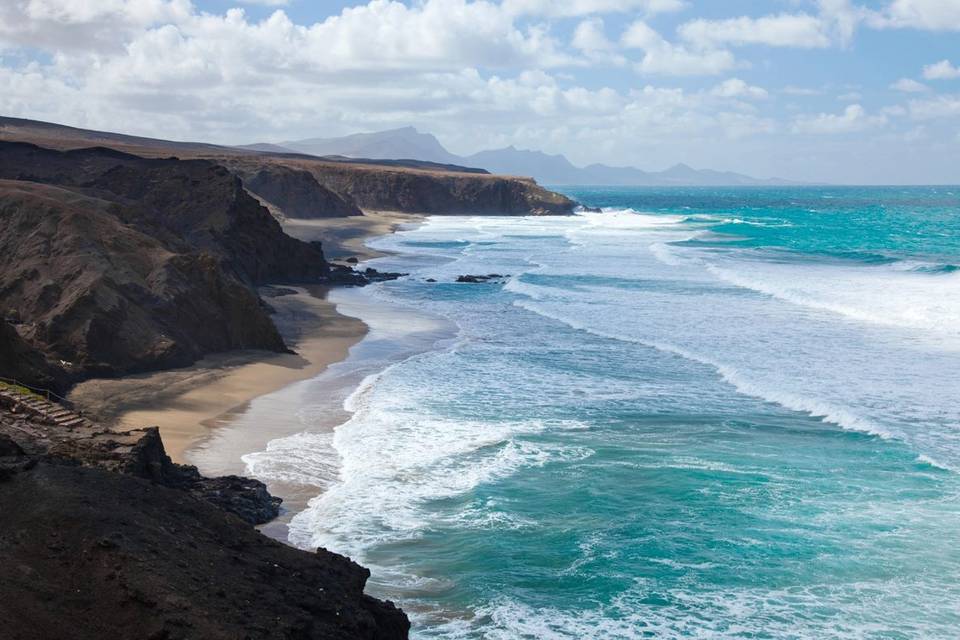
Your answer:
(0, 0), (960, 184)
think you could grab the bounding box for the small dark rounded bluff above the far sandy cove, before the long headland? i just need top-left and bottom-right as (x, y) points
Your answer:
(242, 165), (363, 218)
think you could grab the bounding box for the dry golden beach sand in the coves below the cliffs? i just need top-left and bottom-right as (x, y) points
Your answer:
(69, 212), (422, 463)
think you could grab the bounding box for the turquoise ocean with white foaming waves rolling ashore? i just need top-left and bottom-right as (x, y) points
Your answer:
(245, 187), (960, 640)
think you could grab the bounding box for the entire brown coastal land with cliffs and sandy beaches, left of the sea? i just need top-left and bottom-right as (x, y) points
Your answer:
(0, 118), (575, 638)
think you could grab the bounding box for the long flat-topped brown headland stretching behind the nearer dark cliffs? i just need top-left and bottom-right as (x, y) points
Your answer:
(0, 117), (577, 218)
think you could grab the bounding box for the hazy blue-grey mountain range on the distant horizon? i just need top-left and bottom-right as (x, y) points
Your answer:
(244, 127), (797, 186)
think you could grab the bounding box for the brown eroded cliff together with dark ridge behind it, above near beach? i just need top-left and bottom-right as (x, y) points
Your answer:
(0, 143), (329, 379)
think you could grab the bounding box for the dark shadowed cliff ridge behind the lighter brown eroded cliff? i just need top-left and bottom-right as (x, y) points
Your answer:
(0, 142), (329, 284)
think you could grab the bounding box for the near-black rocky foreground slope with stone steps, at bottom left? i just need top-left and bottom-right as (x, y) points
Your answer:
(0, 394), (410, 640)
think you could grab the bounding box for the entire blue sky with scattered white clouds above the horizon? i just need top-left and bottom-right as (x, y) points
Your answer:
(0, 0), (960, 184)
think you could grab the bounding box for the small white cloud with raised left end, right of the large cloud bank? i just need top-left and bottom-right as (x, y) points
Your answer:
(621, 20), (736, 76)
